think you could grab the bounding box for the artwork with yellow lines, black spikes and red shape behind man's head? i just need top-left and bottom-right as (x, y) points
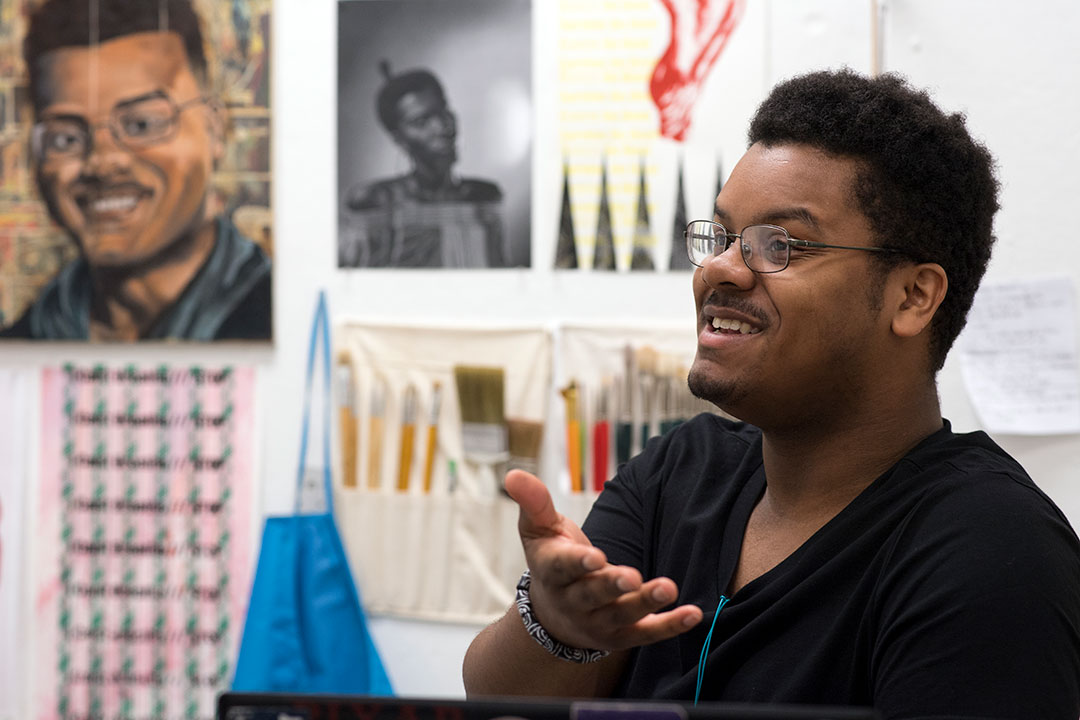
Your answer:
(548, 0), (772, 272)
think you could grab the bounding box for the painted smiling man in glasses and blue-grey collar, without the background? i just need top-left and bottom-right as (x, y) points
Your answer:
(2, 0), (271, 340)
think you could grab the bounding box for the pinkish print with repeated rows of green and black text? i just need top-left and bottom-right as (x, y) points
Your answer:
(33, 366), (254, 720)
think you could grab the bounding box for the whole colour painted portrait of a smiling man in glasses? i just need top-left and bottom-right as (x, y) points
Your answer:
(0, 0), (273, 342)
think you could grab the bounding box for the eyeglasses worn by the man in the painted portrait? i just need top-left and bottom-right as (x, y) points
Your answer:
(30, 91), (207, 162)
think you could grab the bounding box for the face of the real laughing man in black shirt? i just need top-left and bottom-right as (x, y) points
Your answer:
(689, 145), (889, 427)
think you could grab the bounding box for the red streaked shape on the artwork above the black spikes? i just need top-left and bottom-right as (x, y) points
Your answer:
(649, 0), (745, 142)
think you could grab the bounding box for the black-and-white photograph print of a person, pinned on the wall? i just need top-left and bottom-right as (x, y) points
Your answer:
(338, 0), (532, 268)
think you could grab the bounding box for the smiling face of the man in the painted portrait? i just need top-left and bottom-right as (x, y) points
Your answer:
(37, 32), (221, 267)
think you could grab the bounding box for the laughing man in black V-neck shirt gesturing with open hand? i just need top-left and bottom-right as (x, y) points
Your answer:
(464, 71), (1080, 720)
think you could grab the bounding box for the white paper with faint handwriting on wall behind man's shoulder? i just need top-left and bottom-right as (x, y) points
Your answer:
(958, 277), (1080, 435)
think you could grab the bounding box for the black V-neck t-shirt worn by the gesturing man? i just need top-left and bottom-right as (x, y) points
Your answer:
(584, 415), (1080, 720)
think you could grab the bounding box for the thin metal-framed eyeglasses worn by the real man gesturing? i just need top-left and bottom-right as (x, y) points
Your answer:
(684, 220), (903, 273)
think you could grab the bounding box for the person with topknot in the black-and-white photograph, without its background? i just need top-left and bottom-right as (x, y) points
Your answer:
(339, 63), (507, 268)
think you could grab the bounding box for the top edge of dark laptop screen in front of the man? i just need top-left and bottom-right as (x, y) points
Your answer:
(216, 692), (881, 720)
